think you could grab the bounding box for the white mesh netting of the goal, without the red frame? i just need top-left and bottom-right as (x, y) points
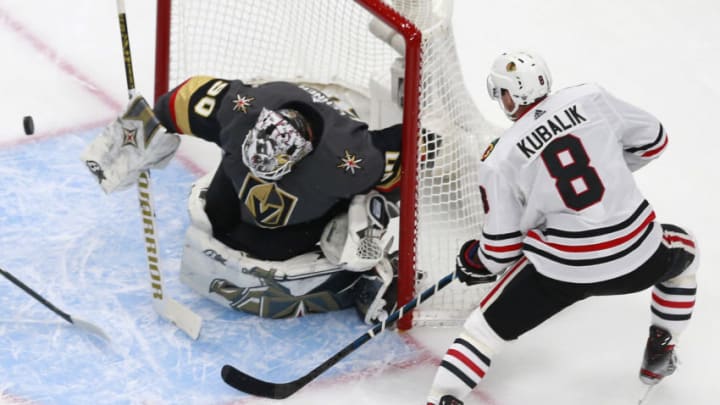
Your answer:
(162, 0), (498, 324)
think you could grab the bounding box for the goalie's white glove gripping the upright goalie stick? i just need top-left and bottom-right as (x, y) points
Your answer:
(81, 94), (180, 194)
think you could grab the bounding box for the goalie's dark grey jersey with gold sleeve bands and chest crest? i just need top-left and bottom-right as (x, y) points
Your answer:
(155, 76), (401, 260)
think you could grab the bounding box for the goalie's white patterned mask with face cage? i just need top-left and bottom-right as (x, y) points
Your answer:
(242, 108), (313, 181)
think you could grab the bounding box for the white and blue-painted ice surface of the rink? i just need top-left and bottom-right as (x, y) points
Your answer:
(0, 0), (720, 405)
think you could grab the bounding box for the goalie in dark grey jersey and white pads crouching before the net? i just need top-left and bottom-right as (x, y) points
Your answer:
(82, 76), (401, 323)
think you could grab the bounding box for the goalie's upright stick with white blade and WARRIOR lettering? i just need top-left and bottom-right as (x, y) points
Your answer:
(117, 0), (202, 339)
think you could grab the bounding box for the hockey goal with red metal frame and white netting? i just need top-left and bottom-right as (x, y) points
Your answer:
(155, 0), (498, 329)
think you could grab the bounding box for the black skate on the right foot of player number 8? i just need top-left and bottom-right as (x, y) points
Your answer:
(640, 326), (677, 385)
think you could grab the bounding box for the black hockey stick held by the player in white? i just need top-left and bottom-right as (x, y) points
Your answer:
(222, 272), (455, 399)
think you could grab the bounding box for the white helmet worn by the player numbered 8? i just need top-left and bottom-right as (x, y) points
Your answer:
(487, 51), (552, 119)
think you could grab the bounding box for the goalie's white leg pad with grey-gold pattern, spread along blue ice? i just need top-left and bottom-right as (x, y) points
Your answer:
(180, 174), (348, 317)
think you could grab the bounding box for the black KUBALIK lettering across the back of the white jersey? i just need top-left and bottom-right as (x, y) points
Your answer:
(516, 104), (587, 159)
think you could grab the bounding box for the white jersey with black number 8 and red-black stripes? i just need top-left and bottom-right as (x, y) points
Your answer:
(478, 84), (667, 283)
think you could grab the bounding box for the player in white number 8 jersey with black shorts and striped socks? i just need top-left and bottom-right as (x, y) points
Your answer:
(428, 52), (698, 405)
